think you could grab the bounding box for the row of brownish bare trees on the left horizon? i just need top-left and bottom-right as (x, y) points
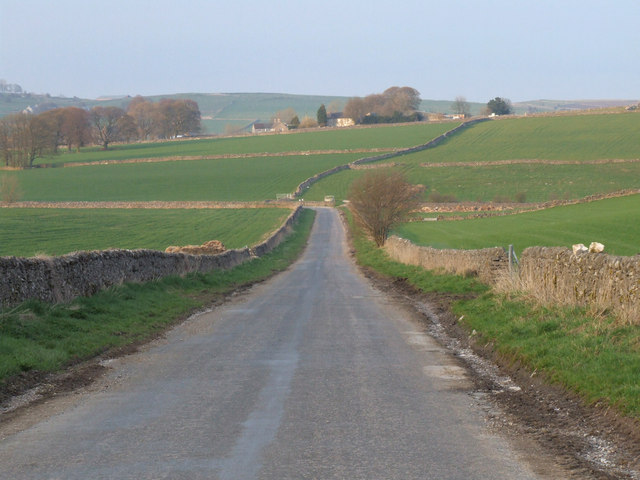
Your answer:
(0, 96), (201, 167)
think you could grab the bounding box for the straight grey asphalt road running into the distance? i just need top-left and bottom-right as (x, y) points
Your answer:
(0, 209), (552, 480)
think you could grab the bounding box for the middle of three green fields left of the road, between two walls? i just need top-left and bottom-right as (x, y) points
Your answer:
(4, 153), (362, 201)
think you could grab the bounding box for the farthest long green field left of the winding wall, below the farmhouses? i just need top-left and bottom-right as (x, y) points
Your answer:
(36, 123), (458, 164)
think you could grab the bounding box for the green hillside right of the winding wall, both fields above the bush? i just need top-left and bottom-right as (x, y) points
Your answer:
(305, 114), (640, 202)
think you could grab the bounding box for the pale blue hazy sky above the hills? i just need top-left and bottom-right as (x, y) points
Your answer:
(0, 0), (640, 103)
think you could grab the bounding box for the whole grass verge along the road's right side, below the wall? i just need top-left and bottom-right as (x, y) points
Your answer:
(344, 208), (640, 419)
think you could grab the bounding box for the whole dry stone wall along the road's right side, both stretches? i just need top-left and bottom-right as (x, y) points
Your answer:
(384, 236), (640, 324)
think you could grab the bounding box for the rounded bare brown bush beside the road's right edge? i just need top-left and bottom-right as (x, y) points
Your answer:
(349, 170), (424, 247)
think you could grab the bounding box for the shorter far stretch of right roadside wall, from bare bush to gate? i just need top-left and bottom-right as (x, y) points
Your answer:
(384, 236), (509, 283)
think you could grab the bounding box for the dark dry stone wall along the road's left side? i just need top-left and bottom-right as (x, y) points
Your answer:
(0, 206), (302, 307)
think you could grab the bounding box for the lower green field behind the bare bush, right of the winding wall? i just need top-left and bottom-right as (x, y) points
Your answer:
(305, 157), (640, 202)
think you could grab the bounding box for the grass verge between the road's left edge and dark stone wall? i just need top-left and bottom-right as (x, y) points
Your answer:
(0, 210), (315, 388)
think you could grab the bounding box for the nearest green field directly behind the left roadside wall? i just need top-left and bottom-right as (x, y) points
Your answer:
(0, 208), (290, 257)
